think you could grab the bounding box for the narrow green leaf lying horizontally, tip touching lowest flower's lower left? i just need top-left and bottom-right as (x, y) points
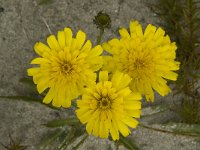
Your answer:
(44, 118), (79, 128)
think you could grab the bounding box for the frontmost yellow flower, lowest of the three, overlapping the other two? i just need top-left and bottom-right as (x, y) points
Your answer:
(76, 71), (141, 140)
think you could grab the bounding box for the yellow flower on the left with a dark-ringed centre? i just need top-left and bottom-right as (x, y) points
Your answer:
(28, 28), (103, 108)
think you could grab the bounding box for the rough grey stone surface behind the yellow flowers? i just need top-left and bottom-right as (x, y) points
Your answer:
(0, 0), (200, 150)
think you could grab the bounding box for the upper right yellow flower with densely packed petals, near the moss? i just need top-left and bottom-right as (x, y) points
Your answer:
(103, 21), (179, 101)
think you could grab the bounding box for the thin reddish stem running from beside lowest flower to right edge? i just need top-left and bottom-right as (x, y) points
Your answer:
(139, 123), (200, 137)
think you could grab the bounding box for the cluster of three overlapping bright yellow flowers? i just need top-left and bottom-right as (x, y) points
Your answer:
(28, 21), (179, 140)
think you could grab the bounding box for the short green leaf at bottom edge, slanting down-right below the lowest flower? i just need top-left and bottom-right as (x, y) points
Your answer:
(119, 135), (139, 150)
